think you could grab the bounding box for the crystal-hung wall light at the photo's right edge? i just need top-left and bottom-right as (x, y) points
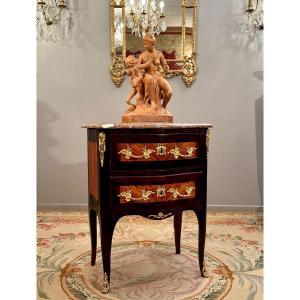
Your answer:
(241, 0), (264, 37)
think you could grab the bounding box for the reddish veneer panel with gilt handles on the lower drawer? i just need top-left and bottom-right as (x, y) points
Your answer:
(118, 181), (196, 203)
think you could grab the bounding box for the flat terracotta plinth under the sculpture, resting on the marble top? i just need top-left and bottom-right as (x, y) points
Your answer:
(122, 113), (173, 123)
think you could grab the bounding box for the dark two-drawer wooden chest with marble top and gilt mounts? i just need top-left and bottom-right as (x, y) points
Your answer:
(82, 123), (211, 292)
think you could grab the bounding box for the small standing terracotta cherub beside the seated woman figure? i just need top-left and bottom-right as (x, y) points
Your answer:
(125, 55), (144, 112)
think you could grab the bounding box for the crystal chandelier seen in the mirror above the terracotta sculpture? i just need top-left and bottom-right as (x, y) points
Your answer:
(127, 0), (167, 37)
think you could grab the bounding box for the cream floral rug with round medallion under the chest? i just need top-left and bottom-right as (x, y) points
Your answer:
(37, 212), (263, 300)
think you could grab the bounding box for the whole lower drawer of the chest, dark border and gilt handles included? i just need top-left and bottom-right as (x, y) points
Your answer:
(110, 172), (206, 214)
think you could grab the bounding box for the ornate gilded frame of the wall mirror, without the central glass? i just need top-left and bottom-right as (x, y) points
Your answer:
(110, 0), (198, 87)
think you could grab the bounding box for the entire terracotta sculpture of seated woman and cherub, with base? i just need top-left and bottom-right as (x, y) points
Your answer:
(122, 33), (173, 123)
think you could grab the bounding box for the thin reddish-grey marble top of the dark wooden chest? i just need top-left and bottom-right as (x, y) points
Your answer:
(81, 123), (212, 129)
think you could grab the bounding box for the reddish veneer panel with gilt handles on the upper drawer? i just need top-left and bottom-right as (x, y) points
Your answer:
(117, 142), (199, 163)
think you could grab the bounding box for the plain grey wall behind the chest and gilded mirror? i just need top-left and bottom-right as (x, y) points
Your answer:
(37, 0), (263, 210)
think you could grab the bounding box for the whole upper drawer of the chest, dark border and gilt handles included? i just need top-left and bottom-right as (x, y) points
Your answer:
(110, 133), (206, 171)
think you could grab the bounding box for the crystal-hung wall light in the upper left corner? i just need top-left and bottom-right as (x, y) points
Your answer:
(36, 0), (72, 43)
